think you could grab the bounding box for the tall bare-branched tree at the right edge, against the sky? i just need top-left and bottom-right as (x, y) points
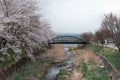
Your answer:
(101, 13), (120, 51)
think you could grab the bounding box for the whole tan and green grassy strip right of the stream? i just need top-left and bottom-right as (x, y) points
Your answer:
(57, 49), (110, 80)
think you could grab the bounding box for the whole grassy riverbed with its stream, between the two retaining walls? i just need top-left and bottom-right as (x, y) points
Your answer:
(10, 45), (111, 80)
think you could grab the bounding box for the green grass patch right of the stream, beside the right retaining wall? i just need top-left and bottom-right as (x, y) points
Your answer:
(78, 61), (109, 80)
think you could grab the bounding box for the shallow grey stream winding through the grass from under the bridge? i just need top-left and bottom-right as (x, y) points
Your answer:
(45, 44), (76, 80)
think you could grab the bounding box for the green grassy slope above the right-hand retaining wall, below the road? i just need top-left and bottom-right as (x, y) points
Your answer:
(87, 44), (120, 72)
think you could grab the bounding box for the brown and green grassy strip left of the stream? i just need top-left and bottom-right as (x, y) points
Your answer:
(9, 45), (66, 80)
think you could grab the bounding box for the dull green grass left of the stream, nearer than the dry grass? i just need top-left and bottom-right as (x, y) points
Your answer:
(10, 57), (54, 80)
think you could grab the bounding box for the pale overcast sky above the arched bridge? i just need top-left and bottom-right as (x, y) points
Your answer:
(40, 0), (120, 33)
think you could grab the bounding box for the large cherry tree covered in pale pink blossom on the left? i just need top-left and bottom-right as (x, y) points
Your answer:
(0, 0), (54, 61)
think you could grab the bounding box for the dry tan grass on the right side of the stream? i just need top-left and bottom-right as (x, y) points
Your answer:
(65, 49), (100, 80)
